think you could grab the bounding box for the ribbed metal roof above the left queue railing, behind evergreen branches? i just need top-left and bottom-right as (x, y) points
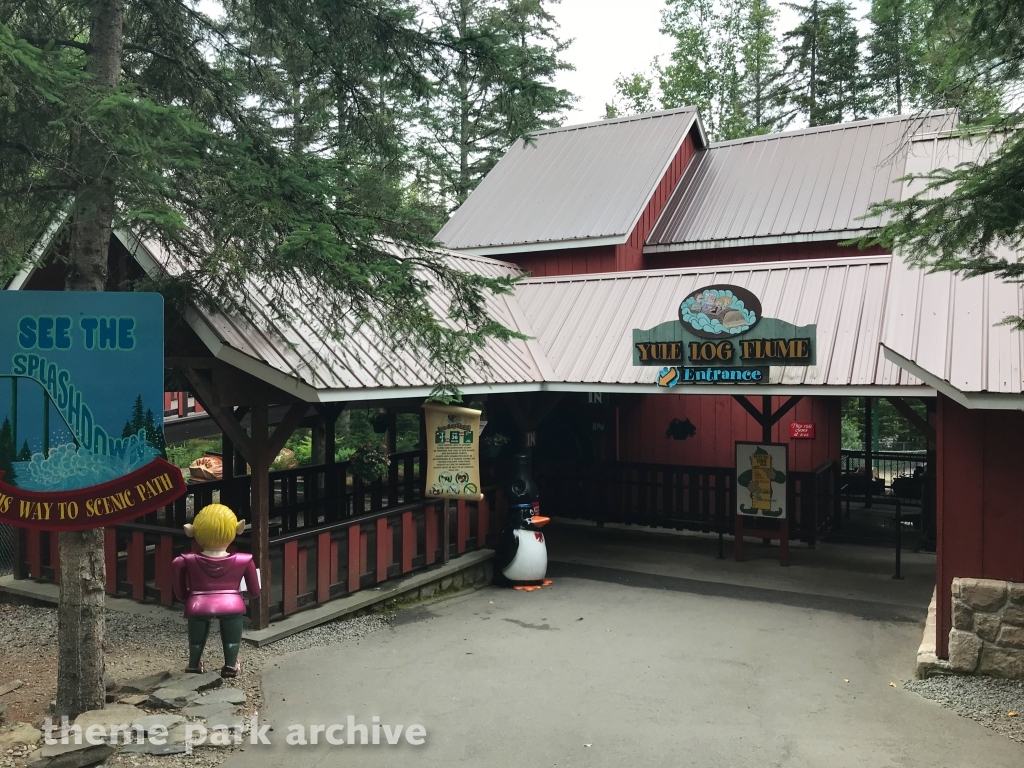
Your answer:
(125, 232), (548, 401)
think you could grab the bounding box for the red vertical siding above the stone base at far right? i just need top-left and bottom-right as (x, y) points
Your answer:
(935, 395), (1024, 657)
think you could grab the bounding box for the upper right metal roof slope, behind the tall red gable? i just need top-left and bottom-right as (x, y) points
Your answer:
(644, 111), (956, 253)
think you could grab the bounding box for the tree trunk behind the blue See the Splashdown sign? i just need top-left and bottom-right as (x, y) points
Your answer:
(55, 0), (125, 717)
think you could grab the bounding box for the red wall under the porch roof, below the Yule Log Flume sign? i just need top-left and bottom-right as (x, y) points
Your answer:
(620, 387), (841, 472)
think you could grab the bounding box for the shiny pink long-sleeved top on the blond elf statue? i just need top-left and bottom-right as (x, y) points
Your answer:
(171, 552), (260, 618)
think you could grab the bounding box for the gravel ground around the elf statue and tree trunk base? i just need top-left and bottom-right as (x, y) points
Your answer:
(0, 603), (392, 768)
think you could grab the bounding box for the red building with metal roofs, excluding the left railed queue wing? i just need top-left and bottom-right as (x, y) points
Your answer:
(438, 110), (1024, 655)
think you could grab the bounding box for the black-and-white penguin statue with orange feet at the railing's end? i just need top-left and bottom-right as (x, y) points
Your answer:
(495, 455), (549, 587)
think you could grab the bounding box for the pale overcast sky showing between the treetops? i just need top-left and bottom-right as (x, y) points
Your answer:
(550, 0), (870, 123)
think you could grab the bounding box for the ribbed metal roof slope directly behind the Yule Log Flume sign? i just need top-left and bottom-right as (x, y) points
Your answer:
(516, 256), (921, 394)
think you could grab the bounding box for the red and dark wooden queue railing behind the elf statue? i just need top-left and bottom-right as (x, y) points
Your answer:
(15, 451), (495, 617)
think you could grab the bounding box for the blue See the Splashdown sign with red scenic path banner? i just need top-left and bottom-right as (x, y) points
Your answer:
(0, 291), (185, 530)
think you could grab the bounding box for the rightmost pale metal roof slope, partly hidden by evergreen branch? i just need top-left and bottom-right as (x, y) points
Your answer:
(883, 136), (1024, 409)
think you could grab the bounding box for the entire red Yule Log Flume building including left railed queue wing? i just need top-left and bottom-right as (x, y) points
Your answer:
(9, 110), (1024, 671)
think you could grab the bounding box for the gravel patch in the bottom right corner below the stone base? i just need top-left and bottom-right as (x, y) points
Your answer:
(903, 675), (1024, 743)
